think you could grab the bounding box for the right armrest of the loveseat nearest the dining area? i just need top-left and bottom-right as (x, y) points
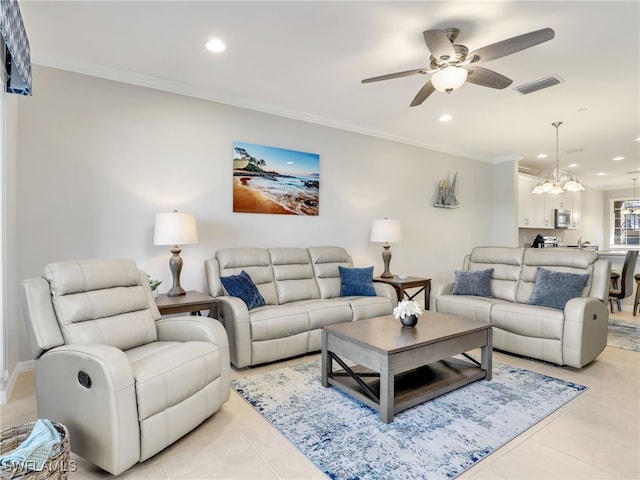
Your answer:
(562, 297), (609, 368)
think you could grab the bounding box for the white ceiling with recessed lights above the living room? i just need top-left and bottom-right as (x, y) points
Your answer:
(20, 0), (640, 190)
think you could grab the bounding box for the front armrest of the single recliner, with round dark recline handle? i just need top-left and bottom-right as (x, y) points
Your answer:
(35, 344), (140, 475)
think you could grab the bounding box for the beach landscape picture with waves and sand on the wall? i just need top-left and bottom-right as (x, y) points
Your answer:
(233, 142), (320, 215)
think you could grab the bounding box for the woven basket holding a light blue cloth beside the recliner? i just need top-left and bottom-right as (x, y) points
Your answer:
(0, 422), (70, 480)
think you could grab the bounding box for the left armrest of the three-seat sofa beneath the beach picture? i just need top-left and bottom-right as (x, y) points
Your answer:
(216, 296), (251, 368)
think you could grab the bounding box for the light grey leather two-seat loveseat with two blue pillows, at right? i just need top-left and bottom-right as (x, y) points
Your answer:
(431, 247), (611, 368)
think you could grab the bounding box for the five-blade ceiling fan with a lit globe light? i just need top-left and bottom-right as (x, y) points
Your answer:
(362, 28), (555, 107)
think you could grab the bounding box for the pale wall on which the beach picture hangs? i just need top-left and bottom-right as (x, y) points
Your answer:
(9, 66), (492, 360)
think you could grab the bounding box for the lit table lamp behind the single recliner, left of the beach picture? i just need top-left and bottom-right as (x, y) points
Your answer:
(153, 210), (198, 297)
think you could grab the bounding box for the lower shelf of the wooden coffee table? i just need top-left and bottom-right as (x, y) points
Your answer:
(327, 357), (487, 414)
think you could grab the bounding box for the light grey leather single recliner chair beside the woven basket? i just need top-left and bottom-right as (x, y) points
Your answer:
(19, 260), (230, 475)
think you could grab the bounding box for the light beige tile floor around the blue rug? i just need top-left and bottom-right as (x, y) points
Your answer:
(0, 312), (640, 480)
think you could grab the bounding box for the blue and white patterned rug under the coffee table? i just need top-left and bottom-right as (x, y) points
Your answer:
(231, 359), (586, 480)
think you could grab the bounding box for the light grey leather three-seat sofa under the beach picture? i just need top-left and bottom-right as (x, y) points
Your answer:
(205, 246), (397, 368)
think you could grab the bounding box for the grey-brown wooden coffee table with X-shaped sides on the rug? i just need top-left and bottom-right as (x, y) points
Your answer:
(322, 311), (492, 423)
